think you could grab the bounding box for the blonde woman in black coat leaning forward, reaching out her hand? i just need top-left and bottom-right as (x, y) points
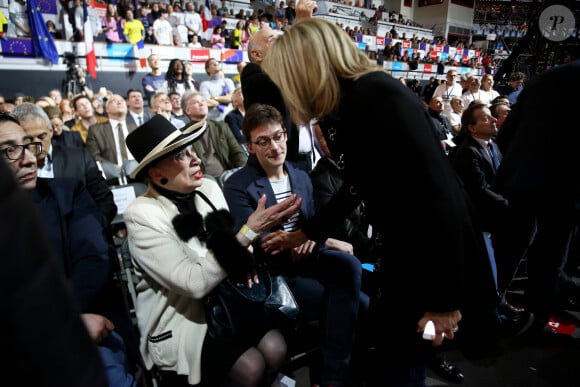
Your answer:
(262, 18), (496, 386)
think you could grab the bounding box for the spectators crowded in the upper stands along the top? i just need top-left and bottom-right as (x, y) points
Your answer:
(1, 0), (526, 71)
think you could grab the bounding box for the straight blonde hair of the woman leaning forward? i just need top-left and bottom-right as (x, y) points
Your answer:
(261, 18), (385, 124)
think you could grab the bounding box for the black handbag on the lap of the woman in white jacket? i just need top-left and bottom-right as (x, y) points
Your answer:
(205, 269), (300, 338)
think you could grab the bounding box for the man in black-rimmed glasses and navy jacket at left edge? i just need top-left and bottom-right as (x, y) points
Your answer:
(0, 115), (135, 387)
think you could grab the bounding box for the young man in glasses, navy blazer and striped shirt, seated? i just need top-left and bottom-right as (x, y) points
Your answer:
(223, 103), (368, 386)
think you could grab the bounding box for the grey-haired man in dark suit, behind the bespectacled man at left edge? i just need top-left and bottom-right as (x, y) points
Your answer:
(13, 103), (117, 224)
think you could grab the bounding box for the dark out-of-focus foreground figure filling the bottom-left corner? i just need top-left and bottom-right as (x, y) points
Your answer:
(0, 145), (108, 387)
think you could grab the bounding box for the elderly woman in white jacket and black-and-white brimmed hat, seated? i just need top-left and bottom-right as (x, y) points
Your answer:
(123, 115), (301, 386)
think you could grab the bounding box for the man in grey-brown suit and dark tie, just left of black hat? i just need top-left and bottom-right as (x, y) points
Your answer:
(87, 94), (136, 185)
